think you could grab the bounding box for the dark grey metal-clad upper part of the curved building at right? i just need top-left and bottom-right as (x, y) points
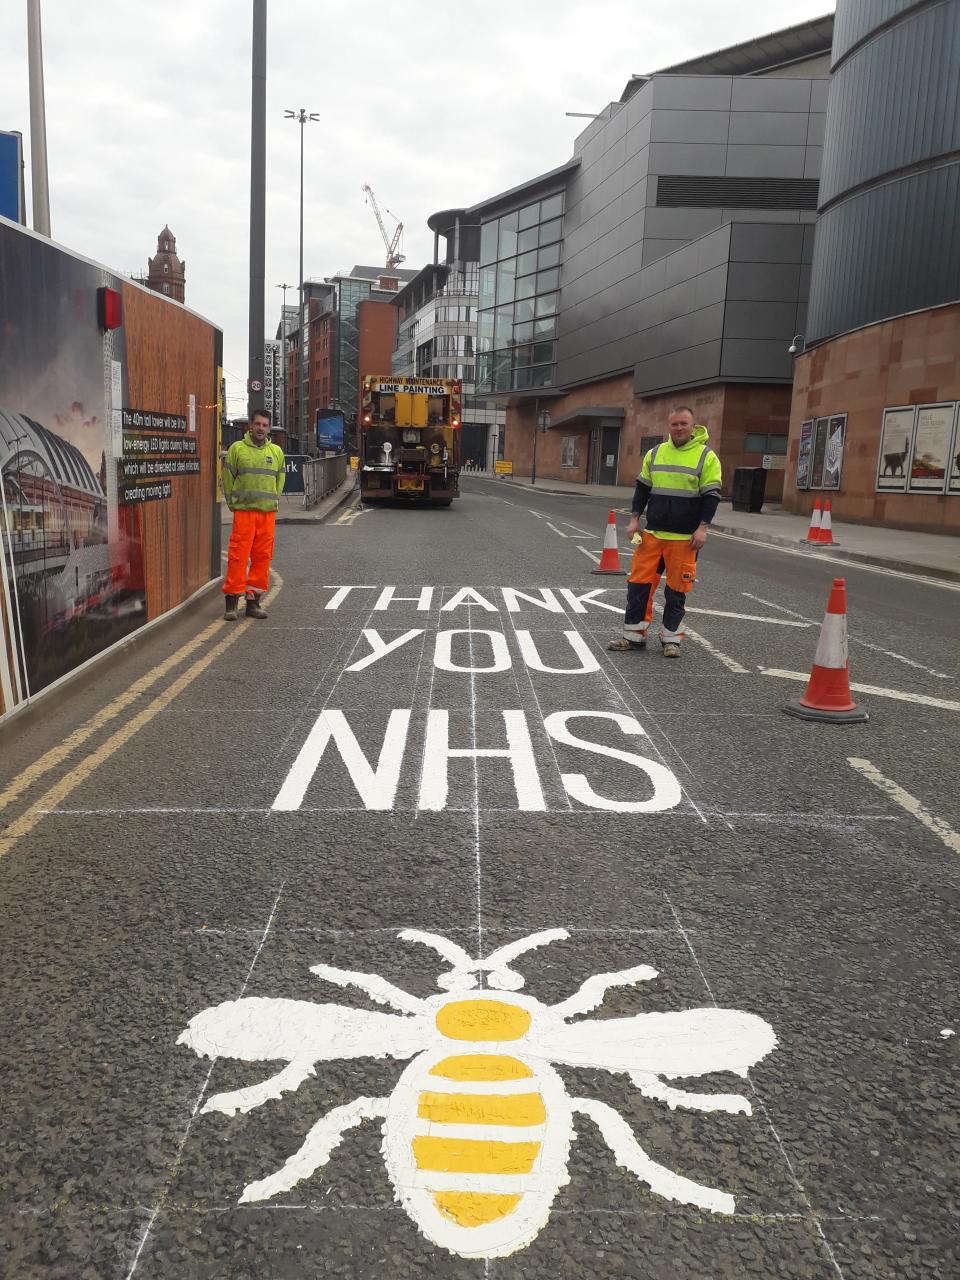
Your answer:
(806, 0), (960, 343)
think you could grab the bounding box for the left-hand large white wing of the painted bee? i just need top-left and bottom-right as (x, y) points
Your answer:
(177, 996), (433, 1062)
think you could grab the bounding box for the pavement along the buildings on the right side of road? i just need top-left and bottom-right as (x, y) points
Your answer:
(484, 476), (960, 581)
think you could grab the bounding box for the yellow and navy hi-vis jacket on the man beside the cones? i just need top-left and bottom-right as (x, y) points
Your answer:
(634, 426), (721, 540)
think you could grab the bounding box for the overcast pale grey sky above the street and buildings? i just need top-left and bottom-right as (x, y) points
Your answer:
(0, 0), (832, 413)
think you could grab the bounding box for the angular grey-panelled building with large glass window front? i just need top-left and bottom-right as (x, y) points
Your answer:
(440, 15), (833, 479)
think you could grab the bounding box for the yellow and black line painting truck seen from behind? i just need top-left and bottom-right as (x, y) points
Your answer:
(360, 374), (463, 507)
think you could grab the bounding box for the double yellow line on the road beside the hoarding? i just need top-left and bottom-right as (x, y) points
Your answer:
(0, 571), (283, 858)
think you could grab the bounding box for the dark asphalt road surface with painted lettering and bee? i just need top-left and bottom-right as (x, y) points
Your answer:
(0, 480), (960, 1280)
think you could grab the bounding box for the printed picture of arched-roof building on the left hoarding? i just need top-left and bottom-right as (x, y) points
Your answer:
(0, 236), (146, 694)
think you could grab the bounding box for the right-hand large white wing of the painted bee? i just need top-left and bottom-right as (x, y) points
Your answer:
(535, 1009), (777, 1079)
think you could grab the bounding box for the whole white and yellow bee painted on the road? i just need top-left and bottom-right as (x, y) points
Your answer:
(178, 929), (777, 1258)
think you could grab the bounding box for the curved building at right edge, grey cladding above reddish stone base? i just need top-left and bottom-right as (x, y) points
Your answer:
(785, 0), (960, 532)
